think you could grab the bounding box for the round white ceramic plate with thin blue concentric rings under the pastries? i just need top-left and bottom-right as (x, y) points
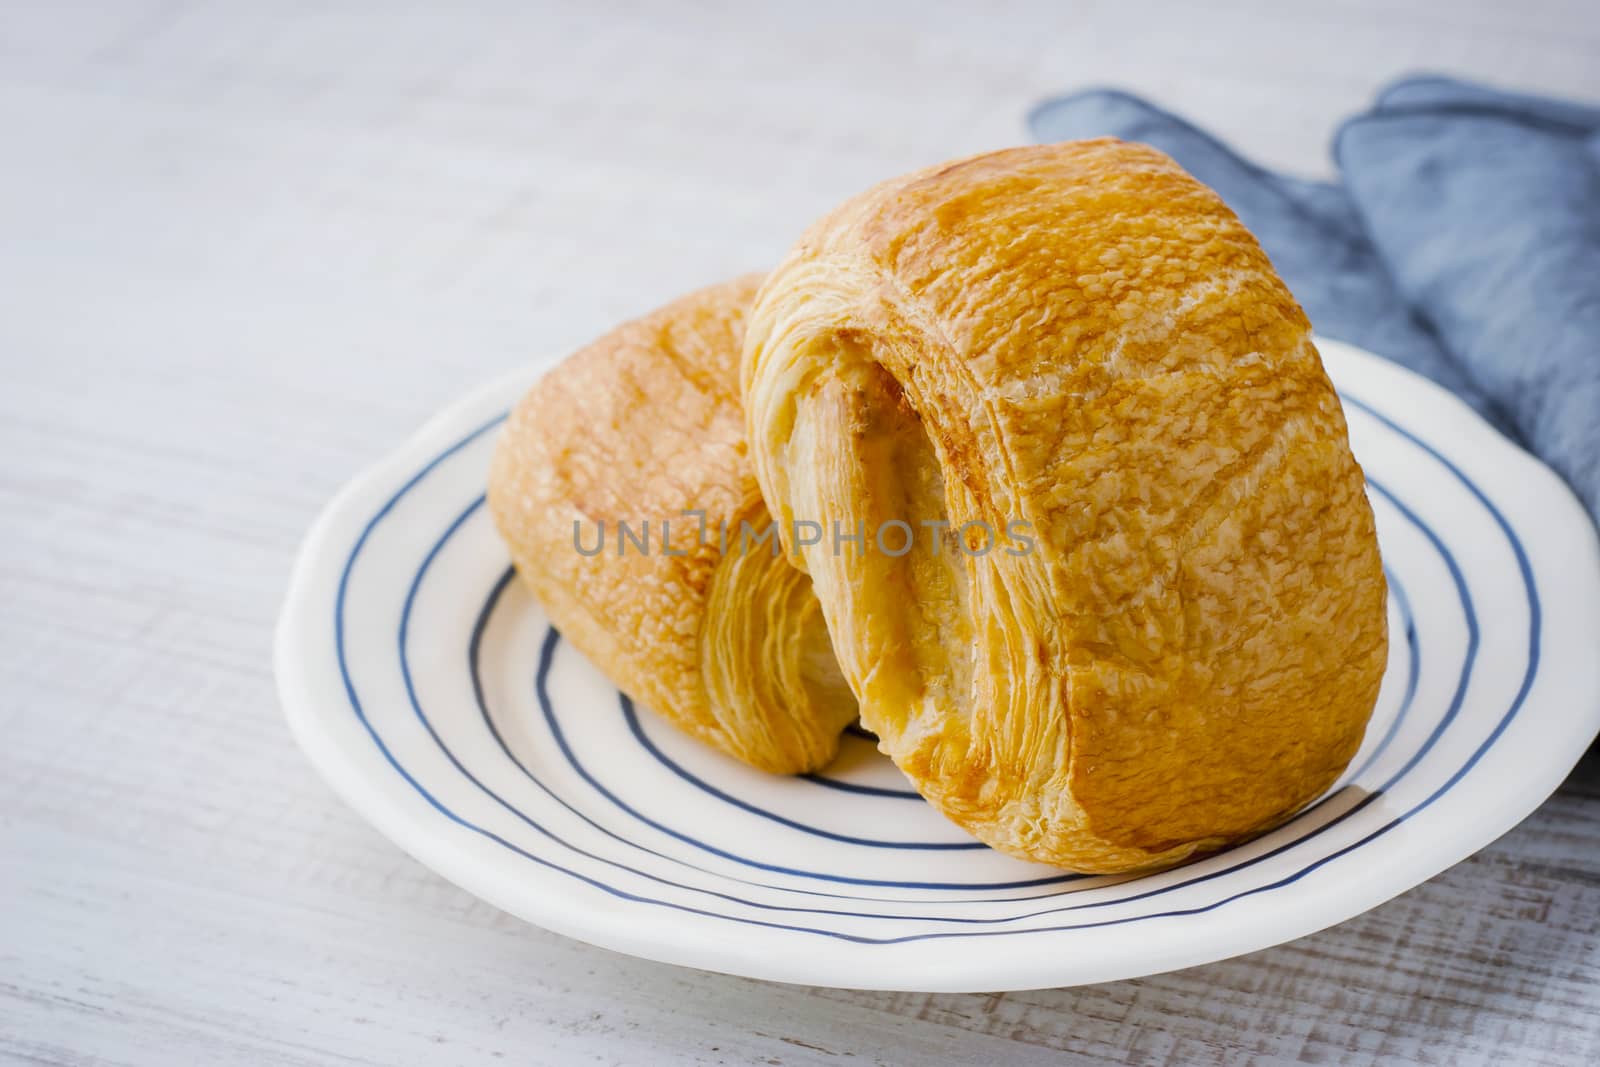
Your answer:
(277, 341), (1600, 990)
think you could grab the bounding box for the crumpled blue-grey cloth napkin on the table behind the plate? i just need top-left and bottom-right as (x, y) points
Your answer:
(1029, 77), (1600, 515)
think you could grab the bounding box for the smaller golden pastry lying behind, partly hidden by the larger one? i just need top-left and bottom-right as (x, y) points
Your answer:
(488, 277), (856, 773)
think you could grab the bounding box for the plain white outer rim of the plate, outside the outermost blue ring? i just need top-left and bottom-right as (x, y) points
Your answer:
(274, 336), (1600, 992)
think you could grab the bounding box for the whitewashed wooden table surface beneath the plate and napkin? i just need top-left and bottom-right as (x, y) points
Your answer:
(0, 0), (1600, 1064)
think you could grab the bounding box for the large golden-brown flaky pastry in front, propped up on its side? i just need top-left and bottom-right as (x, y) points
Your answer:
(742, 139), (1387, 872)
